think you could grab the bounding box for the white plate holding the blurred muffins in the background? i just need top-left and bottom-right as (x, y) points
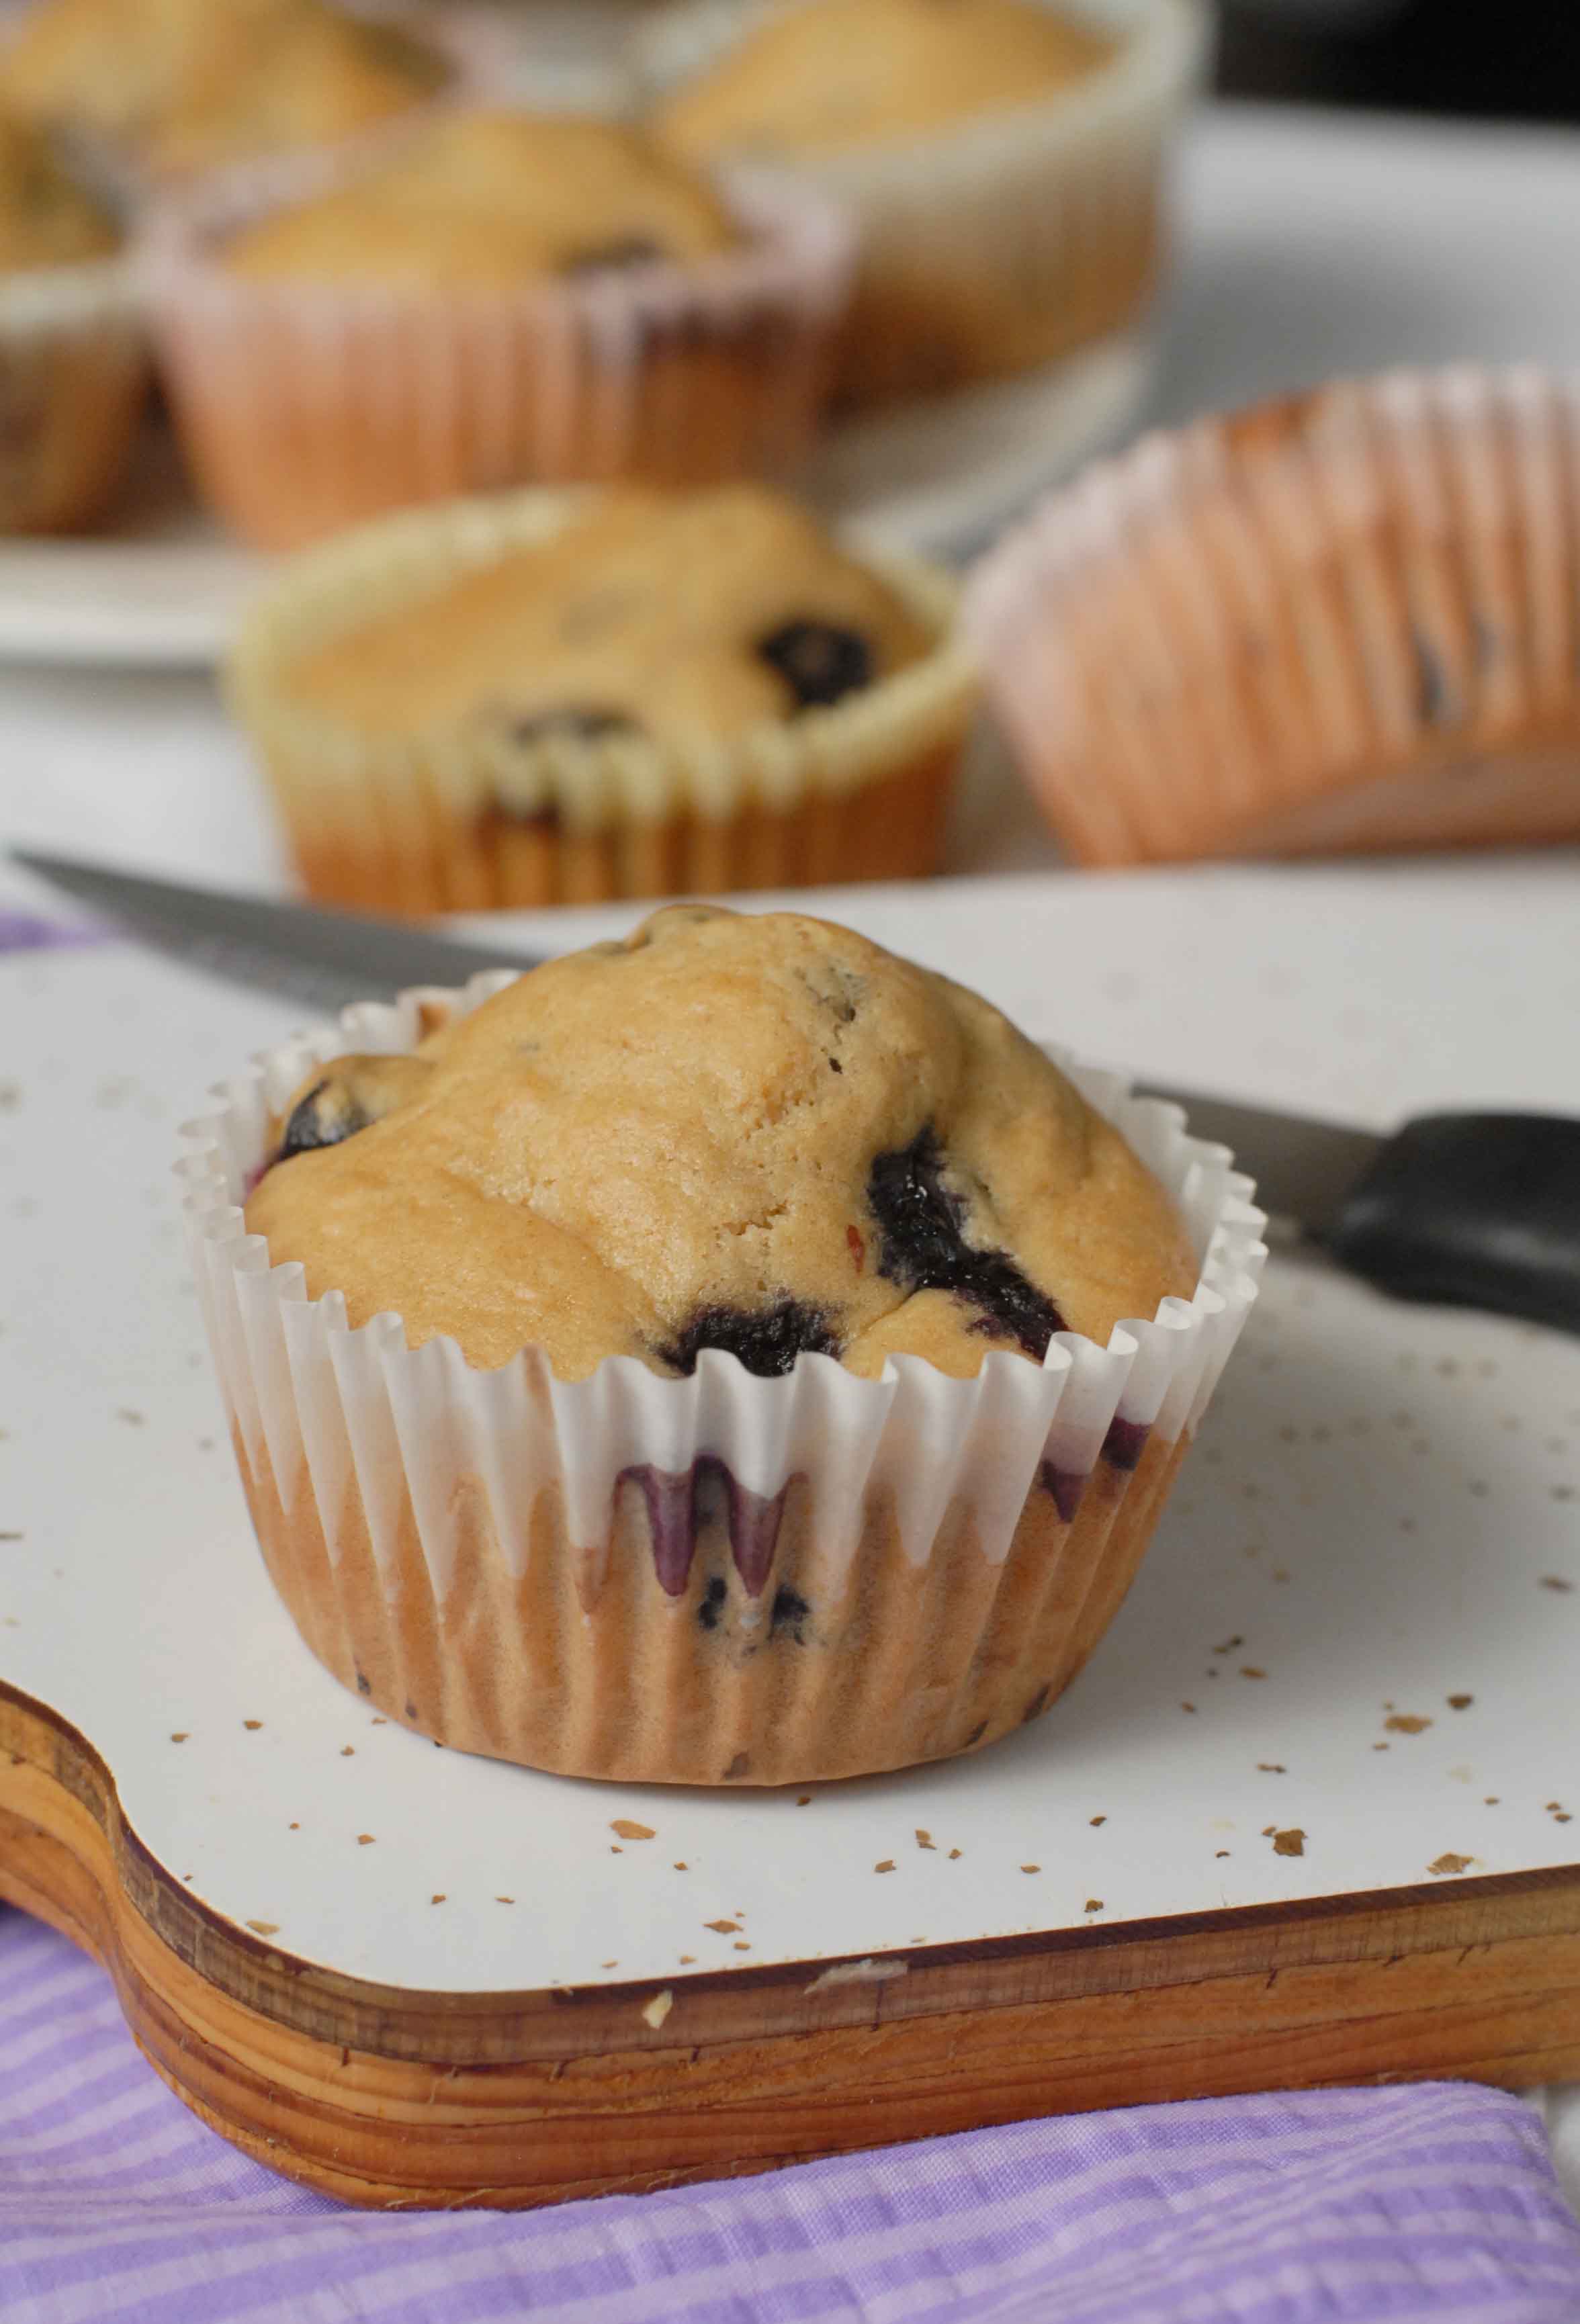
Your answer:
(0, 337), (1150, 669)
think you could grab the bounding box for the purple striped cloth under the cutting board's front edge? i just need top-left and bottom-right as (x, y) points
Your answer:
(0, 1910), (1580, 2324)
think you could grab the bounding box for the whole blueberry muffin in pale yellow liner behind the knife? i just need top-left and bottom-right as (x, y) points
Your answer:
(232, 486), (973, 911)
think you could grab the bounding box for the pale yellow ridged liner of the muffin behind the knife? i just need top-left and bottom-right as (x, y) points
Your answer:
(230, 490), (976, 913)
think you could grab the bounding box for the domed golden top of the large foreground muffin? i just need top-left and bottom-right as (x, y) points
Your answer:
(247, 904), (1196, 1378)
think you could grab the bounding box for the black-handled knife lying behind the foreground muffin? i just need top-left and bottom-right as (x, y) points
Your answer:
(11, 850), (1580, 1332)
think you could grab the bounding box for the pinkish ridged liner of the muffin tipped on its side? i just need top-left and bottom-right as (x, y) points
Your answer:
(967, 365), (1580, 864)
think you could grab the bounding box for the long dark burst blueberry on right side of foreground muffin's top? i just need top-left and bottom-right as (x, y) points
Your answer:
(867, 1122), (1064, 1357)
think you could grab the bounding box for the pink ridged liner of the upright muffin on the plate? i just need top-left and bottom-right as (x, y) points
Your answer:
(142, 140), (852, 549)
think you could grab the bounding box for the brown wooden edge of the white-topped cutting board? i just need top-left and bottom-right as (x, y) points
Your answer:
(0, 1683), (1580, 2208)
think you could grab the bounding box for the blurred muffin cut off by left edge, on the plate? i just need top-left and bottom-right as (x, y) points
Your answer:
(0, 116), (146, 532)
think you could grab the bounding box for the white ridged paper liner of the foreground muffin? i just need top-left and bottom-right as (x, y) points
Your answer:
(181, 974), (1266, 1785)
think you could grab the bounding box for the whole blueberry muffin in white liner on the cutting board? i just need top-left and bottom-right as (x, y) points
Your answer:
(183, 906), (1264, 1785)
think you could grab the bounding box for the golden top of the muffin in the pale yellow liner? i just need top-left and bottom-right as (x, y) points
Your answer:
(283, 484), (934, 746)
